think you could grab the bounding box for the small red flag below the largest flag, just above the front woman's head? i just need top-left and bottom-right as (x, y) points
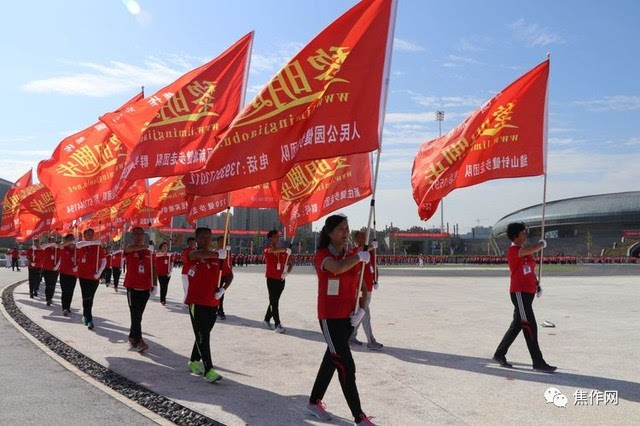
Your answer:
(271, 153), (371, 236)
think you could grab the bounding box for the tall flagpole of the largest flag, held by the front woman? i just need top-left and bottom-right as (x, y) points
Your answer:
(353, 0), (398, 313)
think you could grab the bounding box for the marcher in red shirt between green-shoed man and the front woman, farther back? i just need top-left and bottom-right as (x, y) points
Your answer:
(262, 229), (293, 333)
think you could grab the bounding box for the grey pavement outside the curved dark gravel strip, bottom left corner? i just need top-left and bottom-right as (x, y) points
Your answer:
(0, 268), (154, 425)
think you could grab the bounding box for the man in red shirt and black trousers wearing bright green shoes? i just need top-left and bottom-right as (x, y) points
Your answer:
(184, 228), (227, 383)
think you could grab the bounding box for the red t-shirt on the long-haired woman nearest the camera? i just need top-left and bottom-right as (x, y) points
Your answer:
(315, 247), (360, 319)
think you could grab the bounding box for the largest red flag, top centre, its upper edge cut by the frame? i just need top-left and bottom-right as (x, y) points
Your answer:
(185, 0), (395, 195)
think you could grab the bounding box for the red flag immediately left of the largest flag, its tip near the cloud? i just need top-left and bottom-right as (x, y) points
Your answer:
(100, 32), (253, 180)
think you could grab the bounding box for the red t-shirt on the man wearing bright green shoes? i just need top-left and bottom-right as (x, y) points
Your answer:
(184, 259), (220, 306)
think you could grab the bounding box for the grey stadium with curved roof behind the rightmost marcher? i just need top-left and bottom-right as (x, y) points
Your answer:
(492, 191), (640, 257)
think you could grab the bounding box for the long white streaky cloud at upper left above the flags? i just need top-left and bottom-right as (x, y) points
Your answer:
(22, 55), (195, 97)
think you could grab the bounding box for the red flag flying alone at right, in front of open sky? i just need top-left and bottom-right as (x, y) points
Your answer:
(411, 60), (549, 220)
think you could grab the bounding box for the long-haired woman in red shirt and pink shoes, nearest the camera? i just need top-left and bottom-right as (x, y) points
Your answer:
(307, 215), (373, 425)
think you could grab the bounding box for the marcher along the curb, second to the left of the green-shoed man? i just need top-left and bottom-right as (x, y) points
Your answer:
(76, 228), (107, 330)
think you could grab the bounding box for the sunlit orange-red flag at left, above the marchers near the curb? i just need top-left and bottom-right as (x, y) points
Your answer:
(38, 94), (144, 222)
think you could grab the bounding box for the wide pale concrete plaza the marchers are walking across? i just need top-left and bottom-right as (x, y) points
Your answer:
(2, 267), (640, 425)
